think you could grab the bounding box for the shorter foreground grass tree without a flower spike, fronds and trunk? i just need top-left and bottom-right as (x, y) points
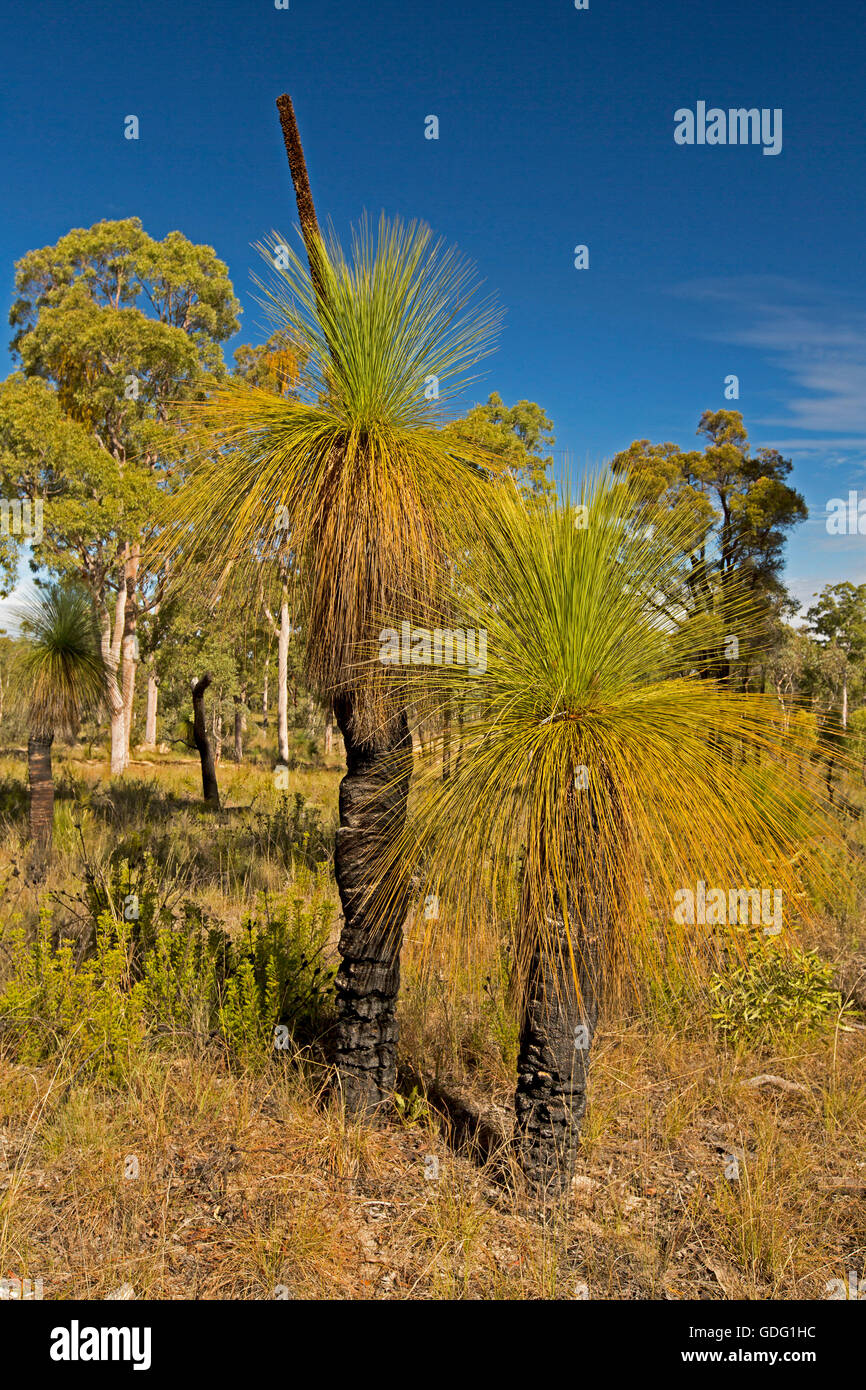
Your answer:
(378, 480), (833, 1190)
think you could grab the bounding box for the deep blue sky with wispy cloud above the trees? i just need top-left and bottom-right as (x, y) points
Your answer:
(0, 0), (866, 614)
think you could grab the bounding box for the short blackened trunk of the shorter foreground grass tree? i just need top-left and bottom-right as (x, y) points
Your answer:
(514, 878), (601, 1195)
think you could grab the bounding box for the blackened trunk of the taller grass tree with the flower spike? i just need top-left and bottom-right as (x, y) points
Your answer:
(334, 698), (411, 1115)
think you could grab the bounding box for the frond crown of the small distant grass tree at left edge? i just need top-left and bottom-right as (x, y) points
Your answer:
(14, 588), (106, 738)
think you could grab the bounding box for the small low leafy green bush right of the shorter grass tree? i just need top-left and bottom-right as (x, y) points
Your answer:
(709, 938), (845, 1047)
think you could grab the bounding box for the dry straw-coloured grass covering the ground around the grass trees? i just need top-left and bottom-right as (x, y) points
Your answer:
(0, 756), (866, 1300)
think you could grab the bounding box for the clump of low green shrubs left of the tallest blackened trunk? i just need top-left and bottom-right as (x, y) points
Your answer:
(0, 874), (334, 1084)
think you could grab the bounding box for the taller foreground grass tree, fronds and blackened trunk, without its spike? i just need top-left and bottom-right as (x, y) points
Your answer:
(161, 218), (498, 1113)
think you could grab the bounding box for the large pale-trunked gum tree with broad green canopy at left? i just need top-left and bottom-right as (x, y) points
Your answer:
(0, 217), (238, 771)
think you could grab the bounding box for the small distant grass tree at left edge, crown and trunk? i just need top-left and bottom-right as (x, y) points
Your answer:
(15, 588), (107, 860)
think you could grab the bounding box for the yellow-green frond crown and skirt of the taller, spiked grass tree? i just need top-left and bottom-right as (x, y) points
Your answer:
(158, 221), (505, 720)
